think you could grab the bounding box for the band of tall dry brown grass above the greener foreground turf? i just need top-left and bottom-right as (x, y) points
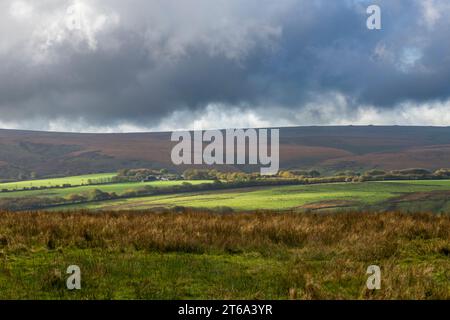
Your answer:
(0, 211), (450, 259)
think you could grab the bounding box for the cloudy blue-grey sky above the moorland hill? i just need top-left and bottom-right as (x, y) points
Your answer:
(0, 0), (450, 132)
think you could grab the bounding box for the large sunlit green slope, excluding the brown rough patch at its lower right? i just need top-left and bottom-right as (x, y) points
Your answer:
(57, 180), (450, 211)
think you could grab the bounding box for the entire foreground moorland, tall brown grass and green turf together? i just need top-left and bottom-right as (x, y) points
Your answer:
(0, 211), (450, 299)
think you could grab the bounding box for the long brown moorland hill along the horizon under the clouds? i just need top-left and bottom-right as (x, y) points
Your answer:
(0, 126), (450, 180)
